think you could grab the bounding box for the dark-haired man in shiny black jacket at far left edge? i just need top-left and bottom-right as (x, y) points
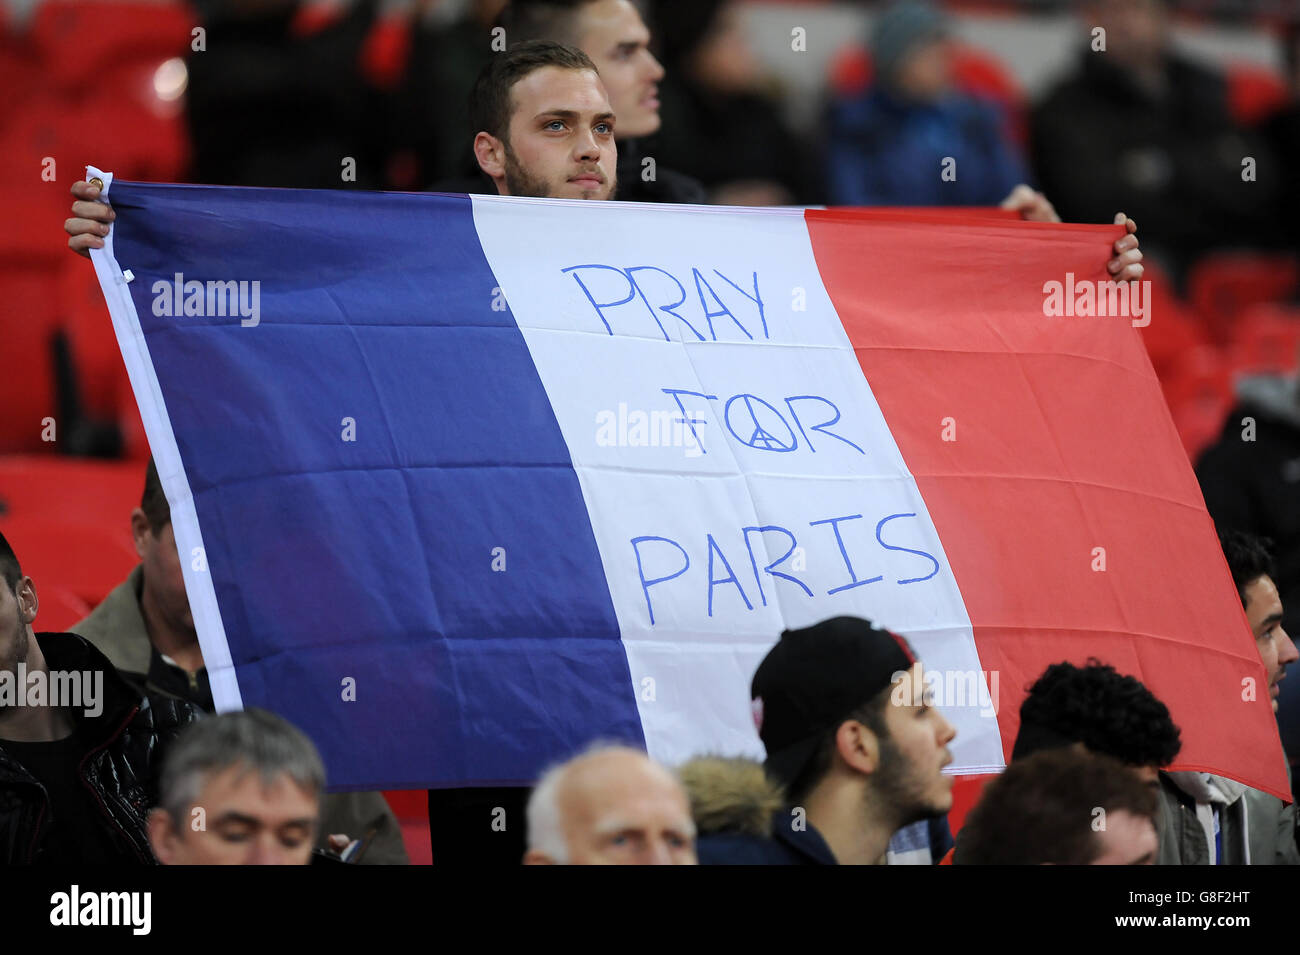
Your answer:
(0, 535), (199, 865)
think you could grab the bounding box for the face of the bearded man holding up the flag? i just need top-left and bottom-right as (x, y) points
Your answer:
(489, 66), (618, 199)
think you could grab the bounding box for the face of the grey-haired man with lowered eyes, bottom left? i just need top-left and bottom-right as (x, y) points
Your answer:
(150, 765), (320, 865)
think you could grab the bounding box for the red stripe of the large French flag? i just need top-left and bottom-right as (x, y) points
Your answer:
(807, 210), (1290, 799)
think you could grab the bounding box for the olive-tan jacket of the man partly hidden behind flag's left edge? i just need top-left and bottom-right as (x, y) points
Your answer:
(73, 564), (410, 865)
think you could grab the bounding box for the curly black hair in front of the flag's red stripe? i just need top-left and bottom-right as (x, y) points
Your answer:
(1011, 659), (1183, 767)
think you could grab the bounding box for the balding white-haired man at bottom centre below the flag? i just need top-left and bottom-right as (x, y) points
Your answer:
(524, 743), (696, 865)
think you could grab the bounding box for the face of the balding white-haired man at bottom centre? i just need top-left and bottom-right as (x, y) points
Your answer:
(558, 751), (696, 865)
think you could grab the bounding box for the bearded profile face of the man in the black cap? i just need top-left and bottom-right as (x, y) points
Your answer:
(871, 663), (957, 825)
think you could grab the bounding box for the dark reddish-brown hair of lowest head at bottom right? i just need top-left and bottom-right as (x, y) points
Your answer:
(953, 747), (1157, 865)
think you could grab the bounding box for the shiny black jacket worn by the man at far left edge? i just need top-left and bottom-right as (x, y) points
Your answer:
(0, 633), (202, 865)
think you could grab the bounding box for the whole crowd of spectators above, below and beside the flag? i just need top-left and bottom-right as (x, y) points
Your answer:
(0, 0), (1300, 864)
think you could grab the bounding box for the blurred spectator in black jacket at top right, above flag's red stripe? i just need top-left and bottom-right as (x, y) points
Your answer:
(1032, 0), (1278, 281)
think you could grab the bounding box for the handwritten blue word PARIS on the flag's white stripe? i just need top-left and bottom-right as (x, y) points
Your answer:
(631, 513), (939, 626)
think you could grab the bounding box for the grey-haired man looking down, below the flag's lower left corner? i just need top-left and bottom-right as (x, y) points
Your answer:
(148, 709), (325, 865)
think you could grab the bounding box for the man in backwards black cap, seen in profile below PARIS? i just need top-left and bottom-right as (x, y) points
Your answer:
(693, 617), (956, 865)
